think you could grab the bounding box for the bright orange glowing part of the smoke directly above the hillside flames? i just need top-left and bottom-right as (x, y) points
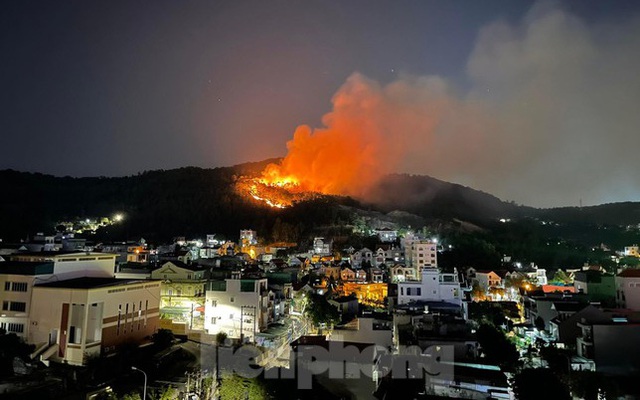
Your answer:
(261, 74), (408, 196)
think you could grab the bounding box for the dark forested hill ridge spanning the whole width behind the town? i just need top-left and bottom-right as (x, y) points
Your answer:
(0, 160), (640, 245)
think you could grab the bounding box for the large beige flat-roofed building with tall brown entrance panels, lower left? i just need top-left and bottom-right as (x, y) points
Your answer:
(28, 277), (160, 365)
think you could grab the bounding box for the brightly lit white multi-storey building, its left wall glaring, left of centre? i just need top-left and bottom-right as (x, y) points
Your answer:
(204, 278), (273, 342)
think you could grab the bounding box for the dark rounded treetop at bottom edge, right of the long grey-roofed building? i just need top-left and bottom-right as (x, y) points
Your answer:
(513, 368), (571, 400)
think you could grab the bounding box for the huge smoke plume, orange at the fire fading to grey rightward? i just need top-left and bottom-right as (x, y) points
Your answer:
(268, 5), (640, 206)
